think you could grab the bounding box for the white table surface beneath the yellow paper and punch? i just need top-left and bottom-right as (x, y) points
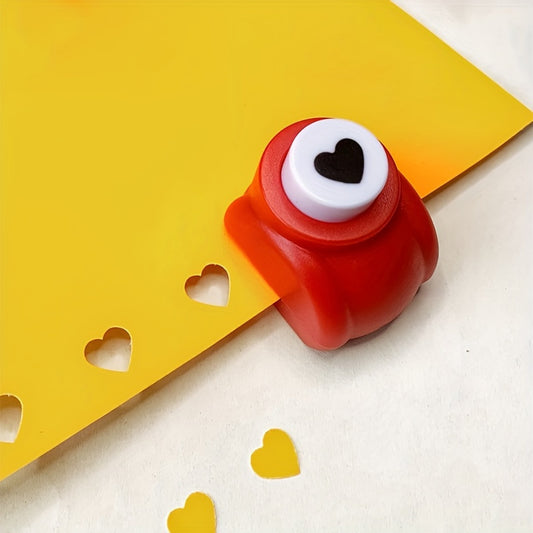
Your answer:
(0, 0), (533, 533)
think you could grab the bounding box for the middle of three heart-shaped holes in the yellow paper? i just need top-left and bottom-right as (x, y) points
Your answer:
(85, 327), (131, 372)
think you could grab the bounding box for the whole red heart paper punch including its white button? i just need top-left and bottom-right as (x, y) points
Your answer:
(225, 118), (438, 350)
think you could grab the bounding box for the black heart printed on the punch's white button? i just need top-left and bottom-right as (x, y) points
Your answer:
(315, 139), (365, 183)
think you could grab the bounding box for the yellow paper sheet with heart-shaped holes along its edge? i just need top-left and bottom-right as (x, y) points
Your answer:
(0, 0), (532, 479)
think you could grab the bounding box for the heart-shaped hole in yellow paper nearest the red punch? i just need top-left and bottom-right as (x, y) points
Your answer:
(185, 264), (229, 307)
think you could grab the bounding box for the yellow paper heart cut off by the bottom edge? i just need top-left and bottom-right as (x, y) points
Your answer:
(167, 492), (216, 533)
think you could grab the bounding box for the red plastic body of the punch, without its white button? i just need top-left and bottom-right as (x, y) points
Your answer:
(225, 119), (438, 350)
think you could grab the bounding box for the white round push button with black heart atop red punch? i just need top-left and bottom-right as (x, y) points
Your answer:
(281, 118), (389, 222)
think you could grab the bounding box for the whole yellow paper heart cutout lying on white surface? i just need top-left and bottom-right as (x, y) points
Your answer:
(250, 429), (300, 479)
